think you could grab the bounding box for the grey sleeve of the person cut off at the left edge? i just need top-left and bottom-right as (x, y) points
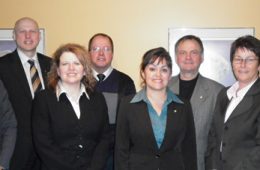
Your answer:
(0, 81), (17, 169)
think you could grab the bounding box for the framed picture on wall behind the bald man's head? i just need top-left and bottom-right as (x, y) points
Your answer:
(0, 28), (45, 57)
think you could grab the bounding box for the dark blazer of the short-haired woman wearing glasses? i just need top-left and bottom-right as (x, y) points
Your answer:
(206, 79), (260, 170)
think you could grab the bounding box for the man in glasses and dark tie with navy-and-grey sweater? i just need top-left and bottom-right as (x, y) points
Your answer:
(88, 33), (136, 170)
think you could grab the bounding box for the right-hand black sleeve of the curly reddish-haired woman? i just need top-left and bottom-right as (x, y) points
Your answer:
(91, 95), (111, 170)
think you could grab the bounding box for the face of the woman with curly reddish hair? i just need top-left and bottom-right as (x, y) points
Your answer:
(57, 52), (85, 85)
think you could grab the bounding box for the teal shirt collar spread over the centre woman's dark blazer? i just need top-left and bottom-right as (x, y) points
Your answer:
(130, 88), (183, 104)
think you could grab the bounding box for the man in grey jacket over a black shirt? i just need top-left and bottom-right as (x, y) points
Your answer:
(168, 35), (223, 170)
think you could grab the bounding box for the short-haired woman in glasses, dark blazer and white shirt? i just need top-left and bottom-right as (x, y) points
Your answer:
(206, 36), (260, 170)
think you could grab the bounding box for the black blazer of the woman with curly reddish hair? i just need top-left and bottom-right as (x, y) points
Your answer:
(32, 90), (110, 170)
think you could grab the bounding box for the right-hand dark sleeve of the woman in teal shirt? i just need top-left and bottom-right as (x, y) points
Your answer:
(182, 101), (197, 170)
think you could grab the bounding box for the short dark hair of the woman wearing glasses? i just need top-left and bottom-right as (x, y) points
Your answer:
(230, 35), (260, 62)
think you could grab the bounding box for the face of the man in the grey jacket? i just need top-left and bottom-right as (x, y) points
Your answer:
(175, 40), (203, 74)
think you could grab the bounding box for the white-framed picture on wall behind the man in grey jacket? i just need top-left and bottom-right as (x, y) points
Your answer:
(169, 28), (255, 86)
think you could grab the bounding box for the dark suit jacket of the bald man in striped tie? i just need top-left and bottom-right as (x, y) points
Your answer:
(0, 50), (51, 170)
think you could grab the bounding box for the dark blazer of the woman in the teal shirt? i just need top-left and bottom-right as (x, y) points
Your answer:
(115, 95), (197, 170)
